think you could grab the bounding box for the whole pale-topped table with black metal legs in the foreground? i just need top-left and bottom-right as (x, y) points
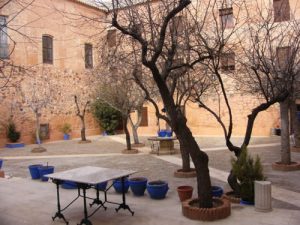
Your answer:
(45, 166), (136, 225)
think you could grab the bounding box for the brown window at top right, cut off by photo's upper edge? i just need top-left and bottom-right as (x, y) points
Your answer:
(273, 0), (290, 22)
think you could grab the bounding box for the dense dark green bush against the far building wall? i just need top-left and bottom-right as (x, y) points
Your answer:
(92, 100), (121, 134)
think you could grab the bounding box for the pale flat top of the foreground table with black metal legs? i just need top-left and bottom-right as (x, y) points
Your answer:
(44, 166), (137, 185)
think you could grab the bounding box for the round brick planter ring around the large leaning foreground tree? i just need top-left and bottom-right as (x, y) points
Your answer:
(182, 198), (231, 221)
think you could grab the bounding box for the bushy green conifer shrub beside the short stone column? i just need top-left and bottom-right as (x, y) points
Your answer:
(231, 147), (265, 202)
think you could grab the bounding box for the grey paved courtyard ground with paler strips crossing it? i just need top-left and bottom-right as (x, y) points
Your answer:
(0, 135), (300, 225)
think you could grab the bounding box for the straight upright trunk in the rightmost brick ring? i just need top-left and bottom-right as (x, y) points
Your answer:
(280, 99), (291, 165)
